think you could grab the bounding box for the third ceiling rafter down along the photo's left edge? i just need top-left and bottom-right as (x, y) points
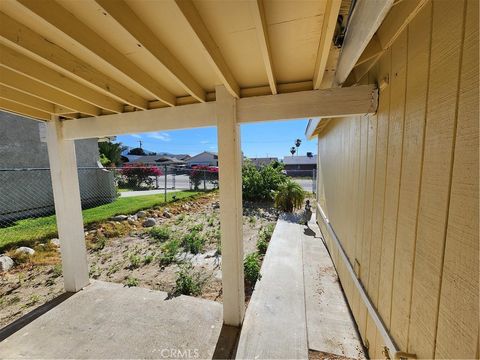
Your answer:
(0, 66), (100, 116)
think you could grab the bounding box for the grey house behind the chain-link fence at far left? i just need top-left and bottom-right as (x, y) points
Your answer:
(0, 111), (116, 222)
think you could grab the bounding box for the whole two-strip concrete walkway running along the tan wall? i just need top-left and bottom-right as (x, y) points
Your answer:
(237, 215), (365, 359)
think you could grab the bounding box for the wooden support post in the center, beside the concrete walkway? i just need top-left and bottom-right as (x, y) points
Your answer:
(216, 86), (245, 326)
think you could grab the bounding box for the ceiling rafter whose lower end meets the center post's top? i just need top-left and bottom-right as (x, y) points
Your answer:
(171, 0), (240, 98)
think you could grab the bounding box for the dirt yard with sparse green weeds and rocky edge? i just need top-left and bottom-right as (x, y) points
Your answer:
(0, 193), (277, 328)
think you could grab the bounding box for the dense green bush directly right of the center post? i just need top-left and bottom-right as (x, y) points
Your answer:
(242, 161), (287, 201)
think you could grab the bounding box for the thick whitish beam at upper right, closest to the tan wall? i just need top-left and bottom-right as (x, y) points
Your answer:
(335, 0), (393, 85)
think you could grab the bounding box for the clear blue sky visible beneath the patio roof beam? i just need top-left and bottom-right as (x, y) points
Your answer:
(117, 120), (317, 158)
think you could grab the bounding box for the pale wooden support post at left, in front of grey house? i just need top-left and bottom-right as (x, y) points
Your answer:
(47, 115), (89, 292)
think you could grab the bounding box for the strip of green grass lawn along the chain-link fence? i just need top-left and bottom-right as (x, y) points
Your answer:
(0, 191), (198, 251)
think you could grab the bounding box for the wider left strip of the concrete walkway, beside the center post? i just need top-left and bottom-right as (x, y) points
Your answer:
(237, 212), (308, 359)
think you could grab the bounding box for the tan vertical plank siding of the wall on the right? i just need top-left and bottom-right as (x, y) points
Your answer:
(318, 0), (479, 358)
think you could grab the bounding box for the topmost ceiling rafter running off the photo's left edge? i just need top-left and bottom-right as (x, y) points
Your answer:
(0, 12), (148, 110)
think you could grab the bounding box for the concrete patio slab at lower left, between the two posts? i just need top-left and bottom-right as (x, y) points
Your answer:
(0, 281), (223, 359)
